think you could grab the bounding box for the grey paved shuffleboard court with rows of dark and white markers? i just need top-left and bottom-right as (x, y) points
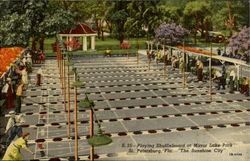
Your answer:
(9, 55), (250, 161)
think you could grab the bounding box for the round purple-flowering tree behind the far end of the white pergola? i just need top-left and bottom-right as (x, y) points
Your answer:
(155, 22), (189, 45)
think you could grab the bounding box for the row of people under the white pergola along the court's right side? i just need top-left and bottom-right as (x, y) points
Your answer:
(147, 50), (249, 96)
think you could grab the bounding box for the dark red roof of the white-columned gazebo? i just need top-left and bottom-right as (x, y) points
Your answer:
(59, 23), (96, 34)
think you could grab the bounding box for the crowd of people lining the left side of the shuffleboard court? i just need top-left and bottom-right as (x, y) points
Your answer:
(0, 51), (45, 160)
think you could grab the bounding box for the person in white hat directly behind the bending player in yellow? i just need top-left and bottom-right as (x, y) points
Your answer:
(5, 111), (23, 147)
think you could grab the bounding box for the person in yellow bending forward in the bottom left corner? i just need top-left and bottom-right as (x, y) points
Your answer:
(3, 132), (35, 160)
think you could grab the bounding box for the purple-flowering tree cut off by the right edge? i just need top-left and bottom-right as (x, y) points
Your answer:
(228, 26), (250, 56)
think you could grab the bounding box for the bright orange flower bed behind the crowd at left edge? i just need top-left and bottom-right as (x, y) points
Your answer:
(0, 47), (24, 77)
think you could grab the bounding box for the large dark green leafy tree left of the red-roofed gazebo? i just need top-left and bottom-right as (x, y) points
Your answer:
(0, 0), (75, 50)
